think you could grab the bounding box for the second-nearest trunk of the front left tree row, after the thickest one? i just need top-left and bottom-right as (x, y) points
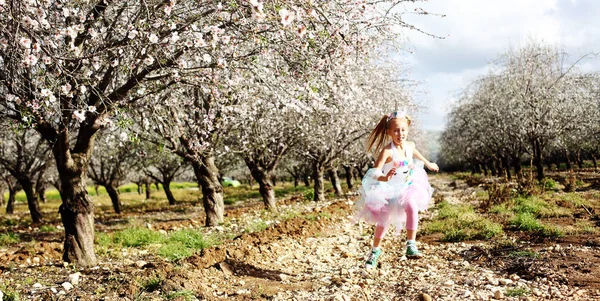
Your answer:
(192, 155), (225, 227)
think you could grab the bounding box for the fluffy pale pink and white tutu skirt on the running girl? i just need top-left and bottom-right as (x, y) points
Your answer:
(354, 160), (433, 234)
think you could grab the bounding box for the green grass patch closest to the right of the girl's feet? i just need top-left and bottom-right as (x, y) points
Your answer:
(423, 201), (503, 241)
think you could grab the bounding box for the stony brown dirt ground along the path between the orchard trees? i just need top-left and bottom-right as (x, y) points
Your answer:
(0, 175), (600, 300)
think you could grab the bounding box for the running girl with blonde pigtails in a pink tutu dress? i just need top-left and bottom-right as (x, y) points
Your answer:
(356, 112), (439, 268)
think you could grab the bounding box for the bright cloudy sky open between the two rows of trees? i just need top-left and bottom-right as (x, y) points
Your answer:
(402, 0), (600, 131)
